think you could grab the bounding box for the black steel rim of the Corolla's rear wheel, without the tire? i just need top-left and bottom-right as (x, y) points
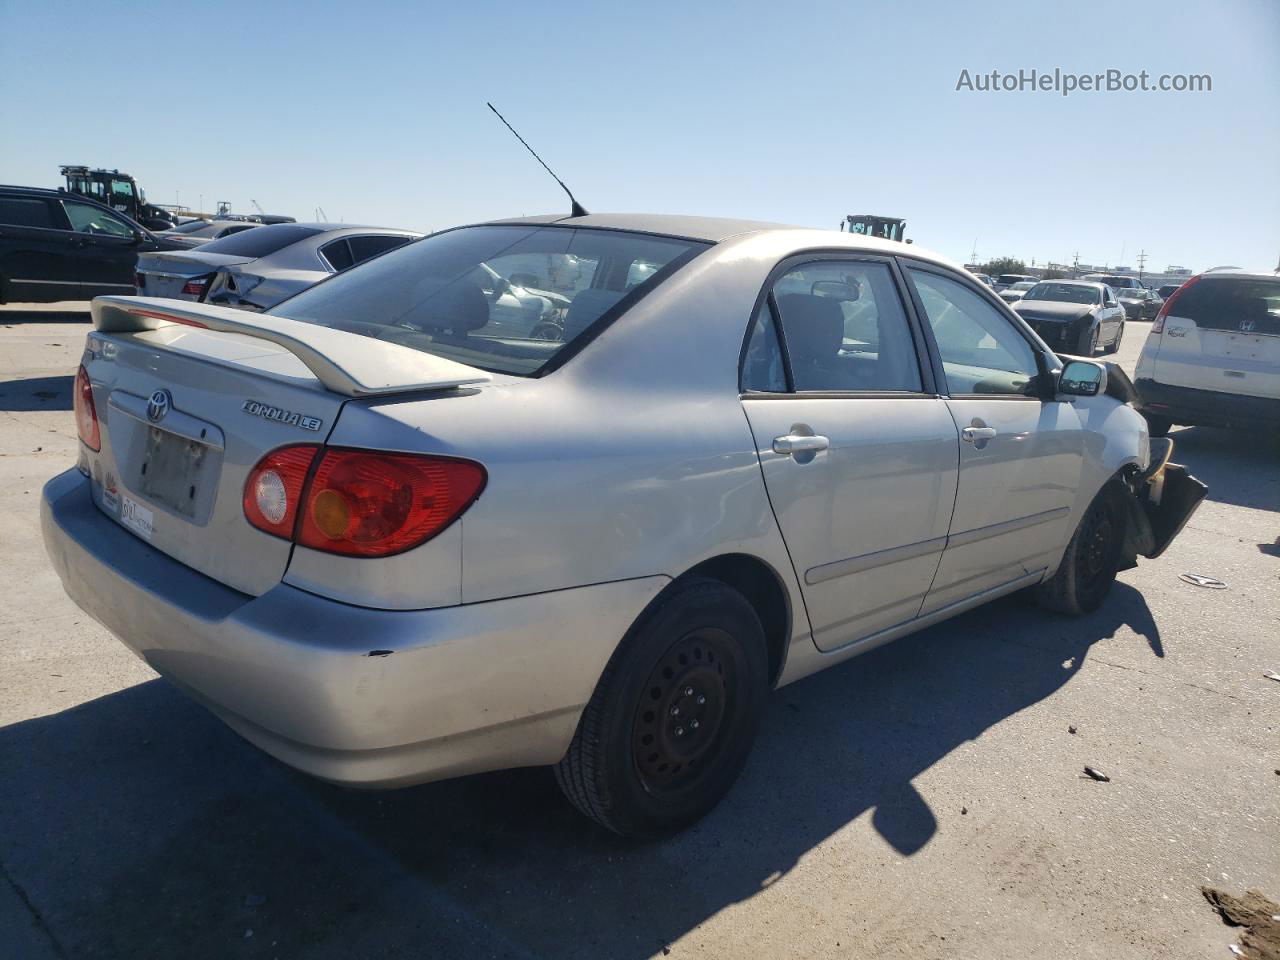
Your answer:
(631, 627), (735, 794)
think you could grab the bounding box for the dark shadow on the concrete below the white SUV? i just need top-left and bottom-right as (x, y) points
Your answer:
(1169, 426), (1280, 511)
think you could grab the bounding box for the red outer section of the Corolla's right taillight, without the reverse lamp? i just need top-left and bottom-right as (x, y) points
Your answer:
(298, 449), (486, 557)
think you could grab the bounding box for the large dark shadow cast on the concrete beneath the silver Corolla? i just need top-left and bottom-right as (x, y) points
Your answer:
(0, 585), (1160, 960)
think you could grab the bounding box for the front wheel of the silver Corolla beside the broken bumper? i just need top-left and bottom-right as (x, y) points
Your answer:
(1036, 484), (1125, 617)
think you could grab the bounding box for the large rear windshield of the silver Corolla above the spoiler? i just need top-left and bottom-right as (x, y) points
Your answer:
(273, 225), (708, 376)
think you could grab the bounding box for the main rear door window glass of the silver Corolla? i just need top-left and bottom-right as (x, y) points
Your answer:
(773, 260), (923, 393)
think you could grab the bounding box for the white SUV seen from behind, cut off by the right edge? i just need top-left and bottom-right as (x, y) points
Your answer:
(1137, 271), (1280, 436)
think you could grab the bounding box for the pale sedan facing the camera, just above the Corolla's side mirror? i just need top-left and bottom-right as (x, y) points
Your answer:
(1014, 280), (1125, 357)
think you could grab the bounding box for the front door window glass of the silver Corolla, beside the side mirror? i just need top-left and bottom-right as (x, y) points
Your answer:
(908, 268), (1037, 396)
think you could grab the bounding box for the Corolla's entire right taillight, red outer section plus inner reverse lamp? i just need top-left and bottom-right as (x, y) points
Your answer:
(244, 444), (486, 557)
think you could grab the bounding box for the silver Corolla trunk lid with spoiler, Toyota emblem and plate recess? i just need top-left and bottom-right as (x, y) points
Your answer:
(84, 297), (488, 595)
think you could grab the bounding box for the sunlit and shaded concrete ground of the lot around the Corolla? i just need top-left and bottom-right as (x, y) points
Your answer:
(0, 305), (1280, 960)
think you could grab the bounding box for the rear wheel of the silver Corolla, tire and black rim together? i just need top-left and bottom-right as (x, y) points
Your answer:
(556, 577), (769, 836)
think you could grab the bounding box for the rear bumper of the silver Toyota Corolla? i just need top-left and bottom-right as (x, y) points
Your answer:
(41, 470), (667, 786)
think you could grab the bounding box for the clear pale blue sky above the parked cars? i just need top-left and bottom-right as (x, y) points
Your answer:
(0, 0), (1280, 269)
